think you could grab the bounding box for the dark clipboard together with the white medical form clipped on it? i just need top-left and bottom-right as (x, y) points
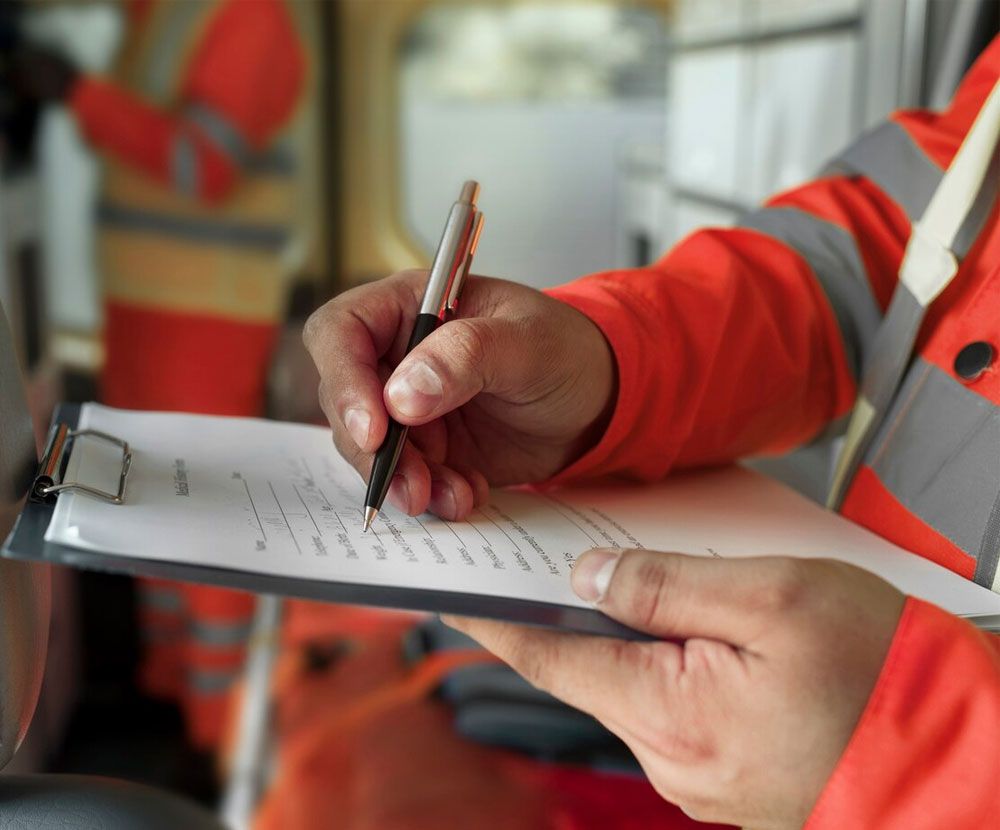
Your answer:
(11, 404), (1000, 640)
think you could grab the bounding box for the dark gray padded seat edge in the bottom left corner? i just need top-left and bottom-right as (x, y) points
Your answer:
(0, 775), (224, 830)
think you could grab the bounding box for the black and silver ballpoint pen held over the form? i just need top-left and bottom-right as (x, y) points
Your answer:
(365, 181), (483, 531)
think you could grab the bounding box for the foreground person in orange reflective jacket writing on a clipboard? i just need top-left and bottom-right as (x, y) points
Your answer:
(304, 32), (1000, 830)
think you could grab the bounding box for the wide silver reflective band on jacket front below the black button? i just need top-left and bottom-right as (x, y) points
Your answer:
(865, 358), (1000, 585)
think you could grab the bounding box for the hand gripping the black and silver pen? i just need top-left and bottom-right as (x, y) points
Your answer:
(304, 185), (617, 520)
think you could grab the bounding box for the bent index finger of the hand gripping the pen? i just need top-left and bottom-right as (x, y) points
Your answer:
(302, 271), (422, 453)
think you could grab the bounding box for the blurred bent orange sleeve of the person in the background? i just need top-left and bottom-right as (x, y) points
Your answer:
(69, 0), (305, 201)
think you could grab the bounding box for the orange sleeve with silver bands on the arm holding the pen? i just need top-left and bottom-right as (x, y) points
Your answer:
(549, 37), (1000, 481)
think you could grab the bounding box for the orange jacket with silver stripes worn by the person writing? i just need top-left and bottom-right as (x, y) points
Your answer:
(551, 38), (1000, 830)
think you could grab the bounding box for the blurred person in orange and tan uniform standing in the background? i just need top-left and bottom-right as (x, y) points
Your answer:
(17, 0), (310, 747)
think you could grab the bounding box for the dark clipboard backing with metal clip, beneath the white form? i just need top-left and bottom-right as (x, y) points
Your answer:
(0, 404), (655, 640)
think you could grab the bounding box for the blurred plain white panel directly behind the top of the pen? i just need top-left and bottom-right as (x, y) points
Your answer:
(401, 100), (664, 288)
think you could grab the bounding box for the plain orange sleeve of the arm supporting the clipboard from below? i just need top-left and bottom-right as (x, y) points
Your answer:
(804, 598), (1000, 830)
